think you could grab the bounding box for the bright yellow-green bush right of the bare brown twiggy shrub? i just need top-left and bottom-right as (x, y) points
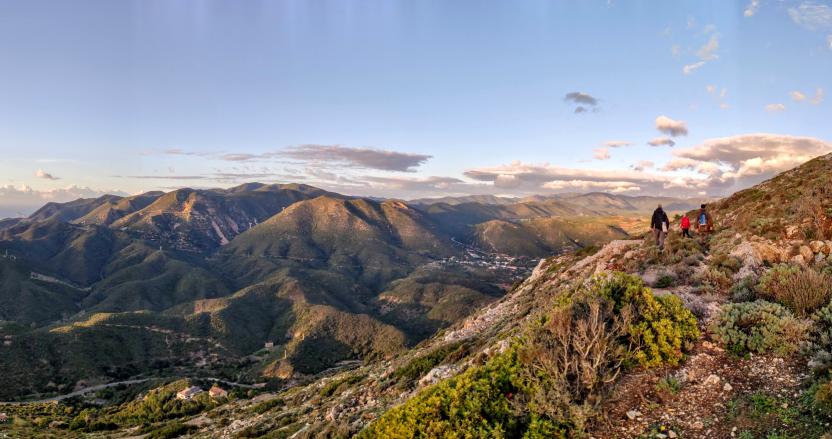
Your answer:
(593, 272), (699, 367)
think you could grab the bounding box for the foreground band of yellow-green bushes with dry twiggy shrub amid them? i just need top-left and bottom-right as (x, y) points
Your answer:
(359, 273), (698, 438)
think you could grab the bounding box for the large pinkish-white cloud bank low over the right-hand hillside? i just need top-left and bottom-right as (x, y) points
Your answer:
(465, 133), (832, 196)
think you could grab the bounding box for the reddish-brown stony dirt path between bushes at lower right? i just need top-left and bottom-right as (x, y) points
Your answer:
(590, 248), (819, 439)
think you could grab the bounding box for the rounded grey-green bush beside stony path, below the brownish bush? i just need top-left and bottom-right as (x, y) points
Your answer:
(711, 300), (807, 355)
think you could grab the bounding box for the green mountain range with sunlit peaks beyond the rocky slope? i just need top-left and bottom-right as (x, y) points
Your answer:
(0, 183), (699, 398)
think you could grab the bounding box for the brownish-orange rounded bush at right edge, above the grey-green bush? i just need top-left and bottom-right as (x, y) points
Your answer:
(759, 264), (832, 315)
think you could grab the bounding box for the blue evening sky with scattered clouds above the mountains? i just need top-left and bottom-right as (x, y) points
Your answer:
(0, 0), (832, 218)
